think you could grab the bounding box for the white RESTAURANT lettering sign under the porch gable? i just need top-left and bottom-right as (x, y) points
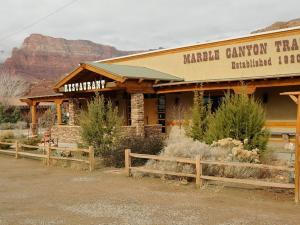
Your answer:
(64, 80), (105, 92)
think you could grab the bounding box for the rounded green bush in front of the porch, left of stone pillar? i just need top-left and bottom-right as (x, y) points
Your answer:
(79, 94), (123, 158)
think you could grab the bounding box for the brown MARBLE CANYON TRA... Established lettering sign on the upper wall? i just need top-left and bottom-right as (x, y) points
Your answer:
(183, 38), (300, 70)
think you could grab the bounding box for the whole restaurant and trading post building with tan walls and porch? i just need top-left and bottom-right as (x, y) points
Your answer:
(21, 27), (300, 140)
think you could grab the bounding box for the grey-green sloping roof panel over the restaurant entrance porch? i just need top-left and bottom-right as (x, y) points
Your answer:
(84, 62), (183, 81)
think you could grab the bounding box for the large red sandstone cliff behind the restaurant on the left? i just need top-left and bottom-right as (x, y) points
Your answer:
(2, 34), (140, 82)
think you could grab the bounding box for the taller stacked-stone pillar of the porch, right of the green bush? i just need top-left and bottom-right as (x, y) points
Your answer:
(131, 93), (145, 136)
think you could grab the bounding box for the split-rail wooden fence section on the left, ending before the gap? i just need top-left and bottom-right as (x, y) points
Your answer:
(0, 141), (95, 171)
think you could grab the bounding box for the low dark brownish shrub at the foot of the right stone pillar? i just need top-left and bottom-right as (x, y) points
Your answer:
(103, 136), (164, 167)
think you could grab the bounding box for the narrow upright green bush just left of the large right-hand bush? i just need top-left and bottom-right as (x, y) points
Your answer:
(185, 91), (211, 141)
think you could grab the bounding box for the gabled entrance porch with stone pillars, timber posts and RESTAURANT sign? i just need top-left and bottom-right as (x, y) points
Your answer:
(21, 62), (181, 140)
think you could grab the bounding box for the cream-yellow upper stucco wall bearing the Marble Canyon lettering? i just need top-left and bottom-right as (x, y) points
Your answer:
(111, 28), (300, 81)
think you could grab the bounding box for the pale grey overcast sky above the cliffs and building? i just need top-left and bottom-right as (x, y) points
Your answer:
(0, 0), (300, 61)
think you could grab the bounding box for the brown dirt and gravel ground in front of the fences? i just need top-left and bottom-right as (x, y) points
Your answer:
(0, 155), (300, 225)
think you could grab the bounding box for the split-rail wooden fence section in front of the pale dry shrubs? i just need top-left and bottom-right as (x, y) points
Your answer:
(125, 149), (295, 195)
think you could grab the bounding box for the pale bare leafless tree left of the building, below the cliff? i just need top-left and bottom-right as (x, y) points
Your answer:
(0, 71), (30, 97)
